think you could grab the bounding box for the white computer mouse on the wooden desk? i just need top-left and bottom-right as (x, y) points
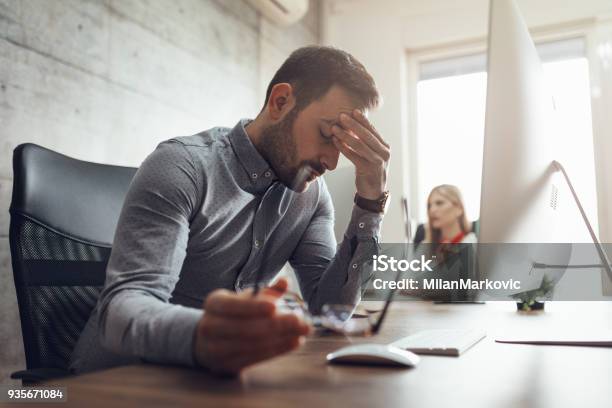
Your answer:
(327, 344), (421, 367)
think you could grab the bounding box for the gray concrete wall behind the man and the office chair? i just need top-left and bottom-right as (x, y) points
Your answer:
(0, 0), (320, 383)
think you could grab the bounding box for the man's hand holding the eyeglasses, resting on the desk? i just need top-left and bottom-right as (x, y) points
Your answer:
(194, 279), (310, 374)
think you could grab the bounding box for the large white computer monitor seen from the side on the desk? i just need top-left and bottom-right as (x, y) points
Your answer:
(478, 0), (572, 295)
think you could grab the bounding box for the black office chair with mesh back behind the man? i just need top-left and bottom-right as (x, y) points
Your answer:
(9, 143), (136, 383)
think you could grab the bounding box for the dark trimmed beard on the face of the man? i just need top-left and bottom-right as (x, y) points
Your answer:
(259, 108), (325, 192)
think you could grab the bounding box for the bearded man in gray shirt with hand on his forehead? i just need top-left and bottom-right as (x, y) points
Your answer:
(71, 46), (390, 373)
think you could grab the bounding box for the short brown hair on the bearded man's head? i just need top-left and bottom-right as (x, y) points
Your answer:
(264, 45), (379, 111)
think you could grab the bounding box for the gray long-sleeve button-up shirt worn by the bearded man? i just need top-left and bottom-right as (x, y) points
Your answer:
(71, 119), (382, 373)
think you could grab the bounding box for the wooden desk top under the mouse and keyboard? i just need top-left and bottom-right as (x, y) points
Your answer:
(49, 302), (612, 408)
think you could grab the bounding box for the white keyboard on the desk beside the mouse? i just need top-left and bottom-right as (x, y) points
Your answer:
(391, 329), (487, 356)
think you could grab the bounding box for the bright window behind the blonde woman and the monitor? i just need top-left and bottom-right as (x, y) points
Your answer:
(415, 38), (596, 226)
